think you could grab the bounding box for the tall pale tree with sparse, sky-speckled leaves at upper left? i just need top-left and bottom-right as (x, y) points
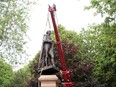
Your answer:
(0, 0), (30, 64)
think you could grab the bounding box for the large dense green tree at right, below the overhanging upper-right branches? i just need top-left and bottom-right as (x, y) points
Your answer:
(80, 24), (116, 87)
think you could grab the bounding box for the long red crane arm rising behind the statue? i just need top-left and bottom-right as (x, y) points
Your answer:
(48, 5), (73, 87)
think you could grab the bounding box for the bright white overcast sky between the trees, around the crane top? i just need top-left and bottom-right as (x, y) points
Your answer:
(24, 0), (103, 65)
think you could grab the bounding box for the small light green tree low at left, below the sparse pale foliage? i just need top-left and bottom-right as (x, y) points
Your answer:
(8, 66), (31, 87)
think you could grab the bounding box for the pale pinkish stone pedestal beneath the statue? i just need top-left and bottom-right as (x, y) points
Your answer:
(38, 75), (58, 87)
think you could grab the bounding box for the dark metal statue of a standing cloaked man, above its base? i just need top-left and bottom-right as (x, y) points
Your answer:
(39, 31), (54, 68)
